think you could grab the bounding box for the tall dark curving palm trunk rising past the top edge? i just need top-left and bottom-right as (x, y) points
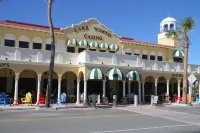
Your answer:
(45, 0), (55, 108)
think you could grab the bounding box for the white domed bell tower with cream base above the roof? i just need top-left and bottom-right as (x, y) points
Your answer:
(158, 17), (181, 49)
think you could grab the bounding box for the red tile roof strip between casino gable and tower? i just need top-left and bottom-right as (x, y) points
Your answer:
(120, 37), (175, 48)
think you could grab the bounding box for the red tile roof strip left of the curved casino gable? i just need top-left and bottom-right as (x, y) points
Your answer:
(0, 20), (61, 32)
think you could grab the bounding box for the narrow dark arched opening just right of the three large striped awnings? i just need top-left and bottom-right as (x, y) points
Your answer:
(144, 76), (155, 102)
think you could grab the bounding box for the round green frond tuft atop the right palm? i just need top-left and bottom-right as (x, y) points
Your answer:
(181, 17), (195, 34)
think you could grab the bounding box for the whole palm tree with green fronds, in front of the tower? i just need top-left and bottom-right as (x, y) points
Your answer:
(166, 17), (195, 103)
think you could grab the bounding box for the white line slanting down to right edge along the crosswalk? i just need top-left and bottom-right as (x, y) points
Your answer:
(119, 108), (200, 126)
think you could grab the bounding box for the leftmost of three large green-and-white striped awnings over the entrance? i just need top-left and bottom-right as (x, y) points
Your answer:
(88, 68), (104, 80)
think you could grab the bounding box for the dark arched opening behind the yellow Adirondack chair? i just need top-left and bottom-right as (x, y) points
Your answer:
(18, 69), (38, 103)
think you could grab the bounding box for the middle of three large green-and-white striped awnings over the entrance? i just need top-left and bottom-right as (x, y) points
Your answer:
(106, 68), (124, 80)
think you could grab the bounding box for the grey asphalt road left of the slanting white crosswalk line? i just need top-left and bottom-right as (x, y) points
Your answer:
(0, 109), (200, 133)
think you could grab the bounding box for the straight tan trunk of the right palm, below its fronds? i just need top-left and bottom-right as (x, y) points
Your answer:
(182, 34), (189, 104)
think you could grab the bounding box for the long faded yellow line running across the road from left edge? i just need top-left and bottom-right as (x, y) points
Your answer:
(0, 114), (142, 123)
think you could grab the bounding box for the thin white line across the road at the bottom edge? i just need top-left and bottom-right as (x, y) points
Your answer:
(95, 124), (194, 133)
